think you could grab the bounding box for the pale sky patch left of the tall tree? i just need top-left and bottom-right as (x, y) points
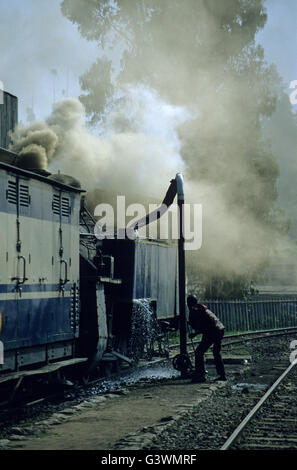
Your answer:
(0, 0), (98, 122)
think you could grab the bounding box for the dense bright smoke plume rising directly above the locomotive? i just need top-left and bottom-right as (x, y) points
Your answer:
(11, 86), (190, 196)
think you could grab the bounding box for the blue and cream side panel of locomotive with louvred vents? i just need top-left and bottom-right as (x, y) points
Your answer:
(0, 169), (80, 370)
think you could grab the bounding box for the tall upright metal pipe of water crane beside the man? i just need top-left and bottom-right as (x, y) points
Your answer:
(176, 173), (187, 360)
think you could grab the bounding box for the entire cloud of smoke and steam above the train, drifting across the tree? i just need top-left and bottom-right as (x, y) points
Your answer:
(8, 0), (292, 294)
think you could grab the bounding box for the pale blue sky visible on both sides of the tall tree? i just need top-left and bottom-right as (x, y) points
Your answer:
(0, 0), (297, 122)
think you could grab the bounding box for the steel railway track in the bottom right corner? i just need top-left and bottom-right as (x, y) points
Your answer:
(220, 361), (297, 450)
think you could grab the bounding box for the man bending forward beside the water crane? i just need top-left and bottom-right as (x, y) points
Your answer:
(187, 295), (226, 383)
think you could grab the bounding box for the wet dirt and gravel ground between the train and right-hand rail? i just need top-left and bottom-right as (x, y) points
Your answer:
(0, 332), (290, 450)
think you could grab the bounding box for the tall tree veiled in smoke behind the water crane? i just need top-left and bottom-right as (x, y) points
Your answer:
(61, 0), (287, 297)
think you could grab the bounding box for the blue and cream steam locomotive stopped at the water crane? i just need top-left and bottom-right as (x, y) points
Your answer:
(0, 93), (178, 398)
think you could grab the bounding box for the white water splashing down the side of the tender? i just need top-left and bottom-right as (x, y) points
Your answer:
(129, 299), (159, 360)
